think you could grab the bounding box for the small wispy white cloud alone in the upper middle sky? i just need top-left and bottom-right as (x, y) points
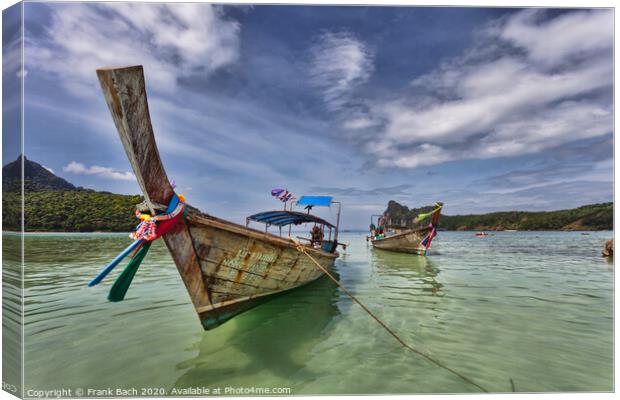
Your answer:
(310, 33), (374, 110)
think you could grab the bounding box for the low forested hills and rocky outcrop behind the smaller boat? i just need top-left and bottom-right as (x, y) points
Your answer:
(386, 200), (614, 231)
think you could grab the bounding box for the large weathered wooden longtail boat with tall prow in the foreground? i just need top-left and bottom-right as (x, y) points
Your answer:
(97, 66), (338, 329)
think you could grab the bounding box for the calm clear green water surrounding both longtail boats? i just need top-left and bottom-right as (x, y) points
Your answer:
(4, 232), (613, 395)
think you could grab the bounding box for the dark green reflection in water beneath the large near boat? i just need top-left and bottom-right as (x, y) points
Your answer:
(174, 271), (340, 386)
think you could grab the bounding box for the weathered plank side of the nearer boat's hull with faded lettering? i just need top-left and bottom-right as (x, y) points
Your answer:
(182, 214), (337, 329)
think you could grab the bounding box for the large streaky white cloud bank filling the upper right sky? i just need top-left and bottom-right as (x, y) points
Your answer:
(362, 10), (613, 168)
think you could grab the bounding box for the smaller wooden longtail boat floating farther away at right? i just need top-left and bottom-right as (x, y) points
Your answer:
(369, 203), (443, 255)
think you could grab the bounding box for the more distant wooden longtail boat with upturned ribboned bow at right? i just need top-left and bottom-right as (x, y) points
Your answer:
(370, 203), (443, 255)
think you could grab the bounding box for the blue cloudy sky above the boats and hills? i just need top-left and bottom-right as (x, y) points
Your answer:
(3, 3), (613, 229)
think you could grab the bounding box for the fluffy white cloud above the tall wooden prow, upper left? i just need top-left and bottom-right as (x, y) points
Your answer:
(25, 3), (240, 96)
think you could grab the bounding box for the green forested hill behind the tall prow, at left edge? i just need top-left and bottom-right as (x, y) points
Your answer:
(2, 156), (143, 232)
